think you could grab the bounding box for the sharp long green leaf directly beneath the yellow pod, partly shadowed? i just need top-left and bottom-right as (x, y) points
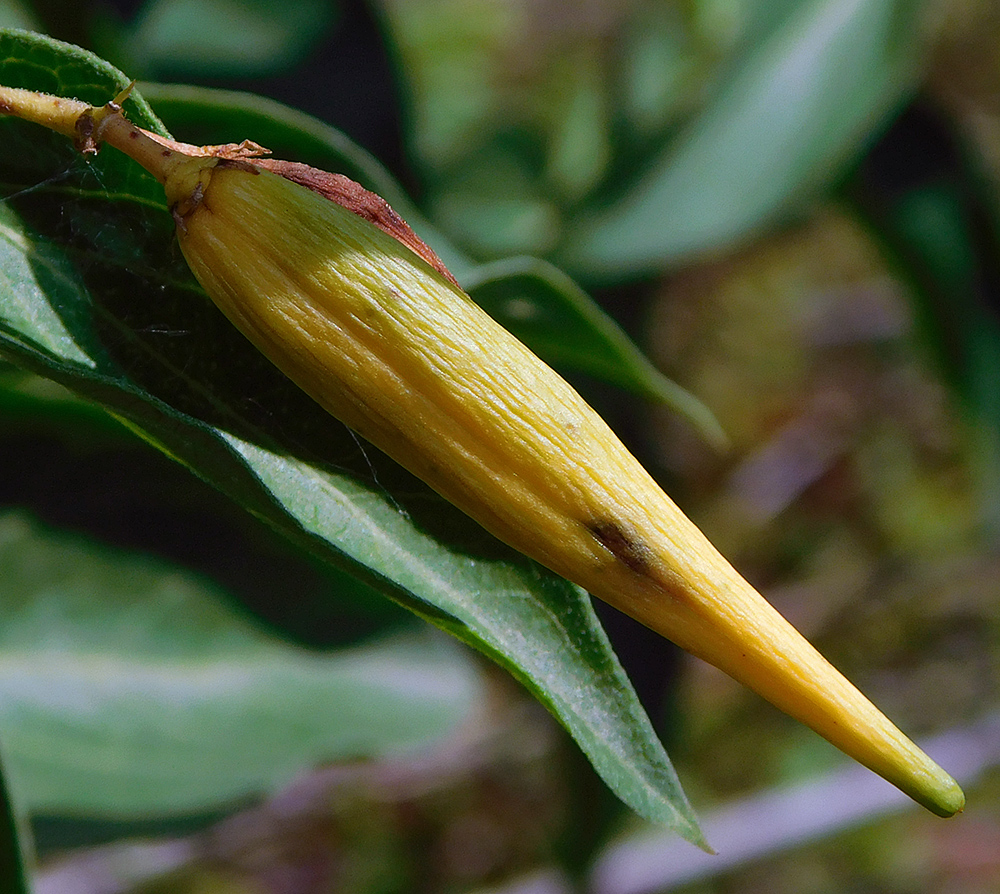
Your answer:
(0, 34), (703, 843)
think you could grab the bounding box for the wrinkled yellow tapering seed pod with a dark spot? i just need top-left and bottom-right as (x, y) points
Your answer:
(0, 84), (965, 816)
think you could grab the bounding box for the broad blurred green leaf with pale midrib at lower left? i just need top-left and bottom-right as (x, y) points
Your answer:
(0, 513), (482, 817)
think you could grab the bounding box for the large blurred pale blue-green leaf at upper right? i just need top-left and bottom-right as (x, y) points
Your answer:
(556, 0), (922, 278)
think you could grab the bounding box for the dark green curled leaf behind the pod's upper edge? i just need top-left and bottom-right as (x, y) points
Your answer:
(141, 84), (726, 448)
